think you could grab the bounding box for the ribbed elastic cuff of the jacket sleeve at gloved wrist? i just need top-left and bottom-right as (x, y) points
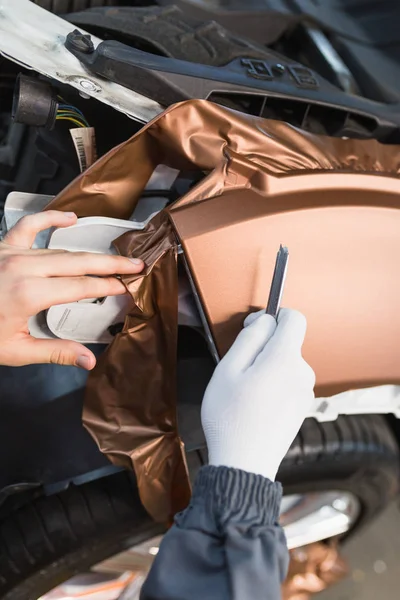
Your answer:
(177, 466), (282, 528)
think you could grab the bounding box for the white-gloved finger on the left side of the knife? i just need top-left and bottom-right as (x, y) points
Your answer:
(221, 311), (276, 371)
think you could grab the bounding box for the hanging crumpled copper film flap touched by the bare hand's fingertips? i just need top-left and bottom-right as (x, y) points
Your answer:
(83, 212), (190, 521)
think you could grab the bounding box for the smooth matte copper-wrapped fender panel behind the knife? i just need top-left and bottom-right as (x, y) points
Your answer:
(172, 175), (400, 396)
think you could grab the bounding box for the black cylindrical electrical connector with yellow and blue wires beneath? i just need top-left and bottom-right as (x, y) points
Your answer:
(12, 73), (58, 129)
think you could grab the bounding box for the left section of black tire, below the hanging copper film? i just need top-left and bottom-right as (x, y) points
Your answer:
(0, 472), (163, 600)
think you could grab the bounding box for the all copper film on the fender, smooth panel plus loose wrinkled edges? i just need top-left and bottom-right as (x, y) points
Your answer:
(49, 100), (400, 520)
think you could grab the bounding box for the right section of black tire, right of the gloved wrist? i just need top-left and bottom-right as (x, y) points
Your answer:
(278, 415), (399, 537)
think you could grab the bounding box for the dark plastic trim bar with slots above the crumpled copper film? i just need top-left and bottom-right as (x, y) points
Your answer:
(65, 29), (400, 143)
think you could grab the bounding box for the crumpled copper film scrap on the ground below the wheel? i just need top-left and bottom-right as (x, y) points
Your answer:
(282, 541), (349, 600)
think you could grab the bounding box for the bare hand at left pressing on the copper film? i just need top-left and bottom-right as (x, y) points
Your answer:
(0, 210), (143, 370)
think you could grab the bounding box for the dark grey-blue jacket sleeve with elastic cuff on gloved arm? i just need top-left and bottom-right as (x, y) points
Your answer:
(141, 466), (288, 600)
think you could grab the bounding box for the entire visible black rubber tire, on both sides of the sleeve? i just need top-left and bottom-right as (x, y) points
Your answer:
(0, 415), (399, 600)
